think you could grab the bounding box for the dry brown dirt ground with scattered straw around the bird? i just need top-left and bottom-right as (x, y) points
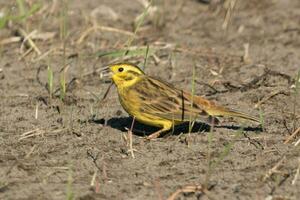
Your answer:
(0, 0), (300, 200)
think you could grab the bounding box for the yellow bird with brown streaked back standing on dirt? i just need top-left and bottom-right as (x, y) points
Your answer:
(101, 63), (259, 139)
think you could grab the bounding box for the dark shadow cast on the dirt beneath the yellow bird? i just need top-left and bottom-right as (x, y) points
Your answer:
(89, 117), (263, 136)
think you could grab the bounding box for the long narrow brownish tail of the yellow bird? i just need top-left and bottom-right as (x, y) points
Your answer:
(206, 106), (260, 123)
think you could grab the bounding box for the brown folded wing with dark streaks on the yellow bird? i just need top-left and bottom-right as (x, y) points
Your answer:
(135, 77), (210, 122)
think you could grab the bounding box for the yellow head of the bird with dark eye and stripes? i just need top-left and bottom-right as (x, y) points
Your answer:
(101, 63), (145, 88)
